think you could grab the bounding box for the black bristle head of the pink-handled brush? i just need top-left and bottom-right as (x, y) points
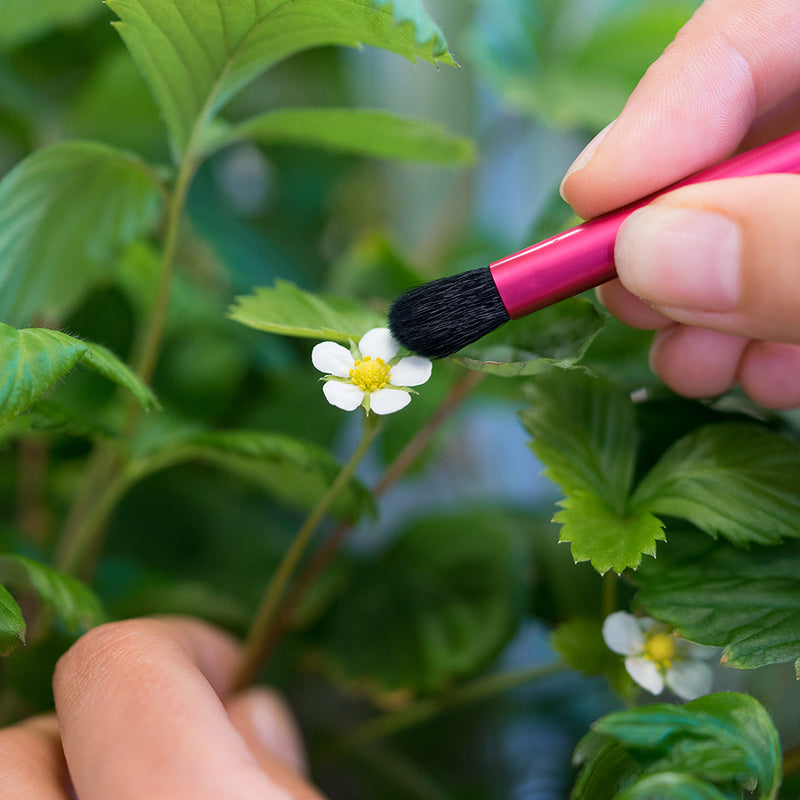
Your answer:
(389, 267), (509, 358)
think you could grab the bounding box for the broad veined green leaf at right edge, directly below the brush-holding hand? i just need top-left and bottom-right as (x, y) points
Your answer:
(633, 424), (800, 545)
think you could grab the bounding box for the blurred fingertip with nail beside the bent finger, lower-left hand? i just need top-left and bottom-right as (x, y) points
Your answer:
(226, 687), (308, 774)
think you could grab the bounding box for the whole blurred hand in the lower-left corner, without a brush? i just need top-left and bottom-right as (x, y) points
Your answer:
(0, 618), (322, 800)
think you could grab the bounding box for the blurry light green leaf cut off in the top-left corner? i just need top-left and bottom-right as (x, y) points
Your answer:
(0, 0), (103, 49)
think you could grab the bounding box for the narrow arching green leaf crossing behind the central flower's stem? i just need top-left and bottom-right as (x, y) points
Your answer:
(131, 430), (374, 521)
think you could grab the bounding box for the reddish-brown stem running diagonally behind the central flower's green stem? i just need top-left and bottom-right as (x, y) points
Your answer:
(239, 372), (484, 660)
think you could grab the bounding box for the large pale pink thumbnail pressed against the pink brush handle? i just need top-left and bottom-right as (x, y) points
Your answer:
(615, 205), (742, 311)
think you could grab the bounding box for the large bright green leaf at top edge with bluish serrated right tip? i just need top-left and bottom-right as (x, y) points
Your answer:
(108, 0), (453, 160)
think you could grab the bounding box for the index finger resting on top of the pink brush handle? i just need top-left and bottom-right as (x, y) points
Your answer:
(562, 0), (800, 218)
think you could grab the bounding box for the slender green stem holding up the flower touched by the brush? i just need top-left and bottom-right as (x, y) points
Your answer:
(234, 415), (380, 689)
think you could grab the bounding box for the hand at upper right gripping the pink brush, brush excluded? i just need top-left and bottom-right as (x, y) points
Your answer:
(562, 0), (800, 408)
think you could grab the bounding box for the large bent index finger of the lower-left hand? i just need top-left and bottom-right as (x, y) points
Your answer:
(53, 619), (320, 800)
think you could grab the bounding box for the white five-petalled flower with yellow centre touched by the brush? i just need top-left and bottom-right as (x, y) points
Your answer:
(311, 328), (432, 414)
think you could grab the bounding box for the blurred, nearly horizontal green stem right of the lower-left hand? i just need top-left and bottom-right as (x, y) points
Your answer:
(336, 661), (569, 751)
